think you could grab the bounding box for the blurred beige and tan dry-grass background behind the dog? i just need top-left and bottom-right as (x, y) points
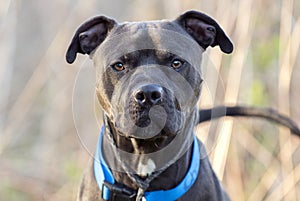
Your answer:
(0, 0), (300, 201)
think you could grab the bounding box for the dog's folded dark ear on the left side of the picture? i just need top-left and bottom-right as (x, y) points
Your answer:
(66, 16), (117, 64)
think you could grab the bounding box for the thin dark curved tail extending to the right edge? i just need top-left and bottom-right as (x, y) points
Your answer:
(198, 106), (300, 137)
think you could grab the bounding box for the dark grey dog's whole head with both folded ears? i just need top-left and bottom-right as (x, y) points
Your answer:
(66, 11), (233, 139)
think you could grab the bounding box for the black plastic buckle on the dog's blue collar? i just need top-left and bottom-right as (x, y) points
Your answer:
(102, 181), (137, 201)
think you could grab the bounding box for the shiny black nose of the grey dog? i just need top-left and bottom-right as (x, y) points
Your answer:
(134, 84), (163, 105)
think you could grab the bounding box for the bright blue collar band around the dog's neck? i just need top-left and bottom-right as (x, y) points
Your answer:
(94, 127), (200, 201)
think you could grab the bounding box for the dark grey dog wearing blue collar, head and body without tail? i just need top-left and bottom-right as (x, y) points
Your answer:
(66, 11), (233, 201)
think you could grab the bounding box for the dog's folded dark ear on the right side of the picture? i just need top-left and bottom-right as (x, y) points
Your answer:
(175, 11), (233, 54)
